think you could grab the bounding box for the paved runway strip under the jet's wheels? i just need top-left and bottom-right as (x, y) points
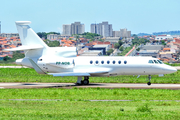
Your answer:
(0, 83), (180, 90)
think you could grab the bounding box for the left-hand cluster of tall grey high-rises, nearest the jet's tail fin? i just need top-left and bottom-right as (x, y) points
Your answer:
(63, 22), (85, 35)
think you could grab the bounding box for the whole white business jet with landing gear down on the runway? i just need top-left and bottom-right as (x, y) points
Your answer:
(3, 21), (177, 85)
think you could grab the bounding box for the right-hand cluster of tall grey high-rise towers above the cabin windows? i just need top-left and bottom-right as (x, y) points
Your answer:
(91, 22), (112, 37)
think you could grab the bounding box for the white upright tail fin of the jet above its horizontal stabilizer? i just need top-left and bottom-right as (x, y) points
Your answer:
(16, 21), (48, 48)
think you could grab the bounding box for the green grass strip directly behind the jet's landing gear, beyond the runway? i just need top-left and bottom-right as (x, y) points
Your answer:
(0, 68), (180, 84)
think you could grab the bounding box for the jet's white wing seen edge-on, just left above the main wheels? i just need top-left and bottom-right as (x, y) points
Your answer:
(48, 72), (90, 76)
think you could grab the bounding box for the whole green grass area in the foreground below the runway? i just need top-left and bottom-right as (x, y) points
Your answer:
(0, 88), (180, 120)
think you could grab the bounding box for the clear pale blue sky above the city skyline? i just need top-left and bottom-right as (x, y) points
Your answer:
(0, 0), (180, 34)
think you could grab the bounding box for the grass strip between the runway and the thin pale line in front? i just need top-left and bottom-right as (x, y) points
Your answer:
(0, 87), (180, 100)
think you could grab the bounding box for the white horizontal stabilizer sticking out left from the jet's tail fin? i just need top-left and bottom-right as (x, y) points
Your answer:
(3, 45), (43, 51)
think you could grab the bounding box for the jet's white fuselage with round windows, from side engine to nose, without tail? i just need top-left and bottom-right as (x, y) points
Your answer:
(32, 56), (177, 76)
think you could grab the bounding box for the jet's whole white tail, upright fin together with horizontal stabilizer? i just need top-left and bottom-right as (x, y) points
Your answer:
(4, 21), (48, 58)
